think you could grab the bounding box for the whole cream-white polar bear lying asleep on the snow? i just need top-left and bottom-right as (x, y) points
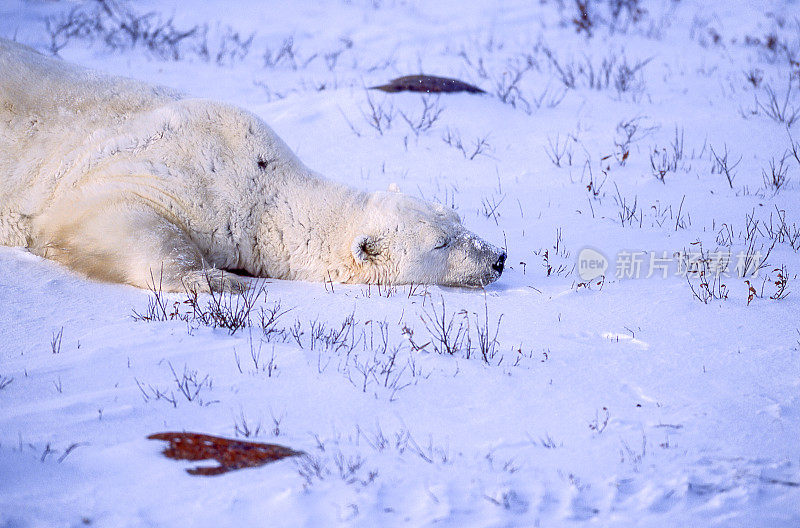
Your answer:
(0, 40), (506, 291)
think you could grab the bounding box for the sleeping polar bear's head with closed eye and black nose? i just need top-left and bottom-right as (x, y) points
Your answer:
(349, 189), (506, 287)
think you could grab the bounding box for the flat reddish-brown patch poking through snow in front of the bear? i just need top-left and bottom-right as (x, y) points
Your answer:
(147, 432), (304, 476)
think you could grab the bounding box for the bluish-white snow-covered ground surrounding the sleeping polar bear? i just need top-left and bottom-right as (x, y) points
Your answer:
(0, 0), (800, 527)
